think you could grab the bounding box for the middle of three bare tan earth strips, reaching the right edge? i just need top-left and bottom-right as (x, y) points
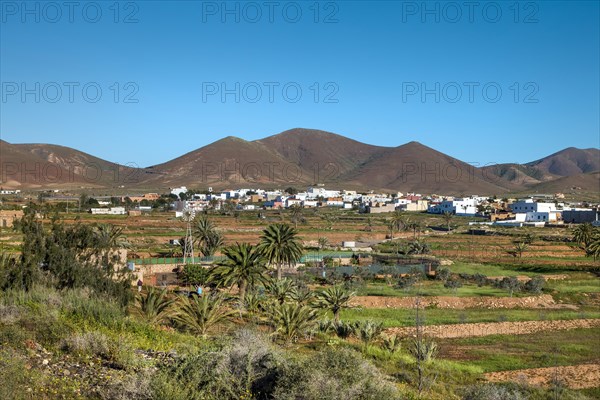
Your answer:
(386, 319), (600, 339)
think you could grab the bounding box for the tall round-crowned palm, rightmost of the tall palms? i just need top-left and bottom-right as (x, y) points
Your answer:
(258, 224), (302, 279)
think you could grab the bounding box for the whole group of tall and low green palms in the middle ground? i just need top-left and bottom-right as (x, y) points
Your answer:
(136, 220), (366, 342)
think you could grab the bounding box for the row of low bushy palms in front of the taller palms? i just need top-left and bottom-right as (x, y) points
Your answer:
(134, 278), (358, 343)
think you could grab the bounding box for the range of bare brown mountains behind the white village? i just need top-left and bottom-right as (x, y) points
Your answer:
(0, 129), (600, 195)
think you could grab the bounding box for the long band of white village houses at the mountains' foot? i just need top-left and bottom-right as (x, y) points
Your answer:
(164, 187), (600, 226)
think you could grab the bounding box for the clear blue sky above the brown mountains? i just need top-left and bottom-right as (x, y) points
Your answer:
(0, 1), (600, 166)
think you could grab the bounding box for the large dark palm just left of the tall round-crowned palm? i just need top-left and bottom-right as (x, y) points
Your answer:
(210, 243), (267, 302)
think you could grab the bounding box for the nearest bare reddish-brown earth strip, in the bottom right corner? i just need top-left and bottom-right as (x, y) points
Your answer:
(484, 363), (600, 389)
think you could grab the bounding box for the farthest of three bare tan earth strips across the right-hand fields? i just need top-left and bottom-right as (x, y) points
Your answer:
(350, 294), (577, 310)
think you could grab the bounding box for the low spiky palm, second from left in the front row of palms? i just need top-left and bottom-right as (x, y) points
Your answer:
(175, 294), (236, 336)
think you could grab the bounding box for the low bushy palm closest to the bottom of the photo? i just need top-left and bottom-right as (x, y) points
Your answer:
(269, 303), (317, 343)
